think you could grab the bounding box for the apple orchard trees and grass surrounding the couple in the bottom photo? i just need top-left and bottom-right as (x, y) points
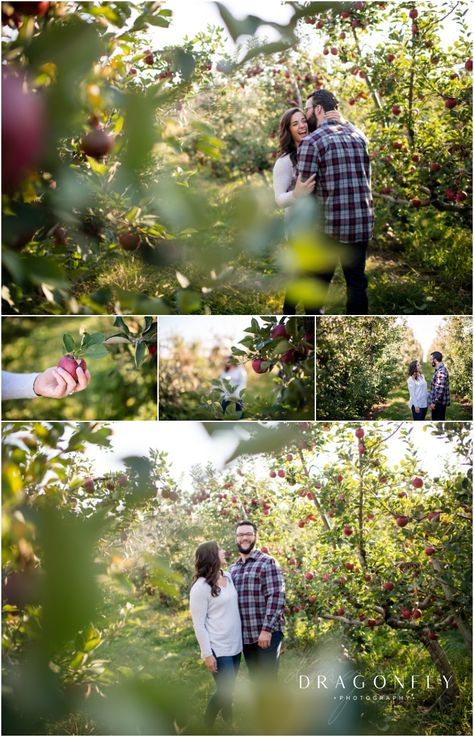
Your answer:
(2, 422), (472, 734)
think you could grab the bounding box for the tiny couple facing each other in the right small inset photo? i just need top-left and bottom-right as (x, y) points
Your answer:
(408, 351), (451, 420)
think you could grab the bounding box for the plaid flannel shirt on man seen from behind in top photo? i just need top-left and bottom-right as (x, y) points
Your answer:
(297, 121), (374, 243)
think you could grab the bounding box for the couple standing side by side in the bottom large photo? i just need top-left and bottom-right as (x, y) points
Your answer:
(190, 520), (285, 730)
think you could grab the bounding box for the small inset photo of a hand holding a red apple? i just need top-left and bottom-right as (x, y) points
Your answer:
(2, 316), (157, 420)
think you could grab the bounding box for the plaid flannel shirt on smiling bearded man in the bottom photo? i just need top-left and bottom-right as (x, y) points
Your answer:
(229, 550), (285, 645)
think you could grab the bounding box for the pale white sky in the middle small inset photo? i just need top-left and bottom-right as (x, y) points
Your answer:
(159, 315), (270, 356)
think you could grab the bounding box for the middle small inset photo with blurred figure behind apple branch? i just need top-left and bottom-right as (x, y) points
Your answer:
(159, 316), (314, 420)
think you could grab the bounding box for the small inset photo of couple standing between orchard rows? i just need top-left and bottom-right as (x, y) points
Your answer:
(316, 315), (472, 420)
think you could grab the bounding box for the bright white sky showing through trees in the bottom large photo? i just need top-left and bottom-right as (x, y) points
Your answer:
(83, 422), (462, 489)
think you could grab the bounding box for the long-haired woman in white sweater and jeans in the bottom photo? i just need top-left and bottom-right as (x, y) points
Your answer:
(190, 540), (242, 728)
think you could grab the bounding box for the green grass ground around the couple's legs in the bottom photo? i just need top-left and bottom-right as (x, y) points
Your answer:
(49, 603), (471, 735)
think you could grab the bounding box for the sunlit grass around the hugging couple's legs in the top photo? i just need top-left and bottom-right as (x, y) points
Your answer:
(9, 179), (472, 315)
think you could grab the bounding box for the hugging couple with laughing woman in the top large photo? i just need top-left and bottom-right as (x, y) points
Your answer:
(273, 90), (374, 315)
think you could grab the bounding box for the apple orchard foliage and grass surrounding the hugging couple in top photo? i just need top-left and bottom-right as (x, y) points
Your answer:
(2, 0), (472, 314)
